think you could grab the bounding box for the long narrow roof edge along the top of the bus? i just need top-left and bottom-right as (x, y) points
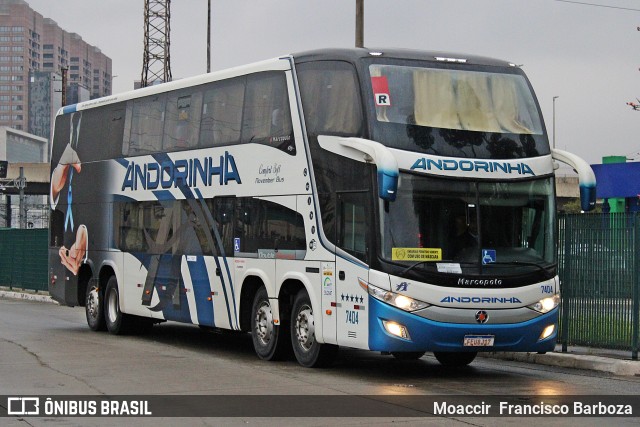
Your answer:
(57, 48), (515, 115)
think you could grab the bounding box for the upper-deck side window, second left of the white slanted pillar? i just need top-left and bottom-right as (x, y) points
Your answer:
(199, 77), (245, 147)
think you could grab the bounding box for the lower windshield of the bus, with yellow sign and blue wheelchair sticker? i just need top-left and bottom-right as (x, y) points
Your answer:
(380, 173), (555, 273)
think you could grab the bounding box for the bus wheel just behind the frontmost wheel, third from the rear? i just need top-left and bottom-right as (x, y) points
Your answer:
(251, 287), (288, 360)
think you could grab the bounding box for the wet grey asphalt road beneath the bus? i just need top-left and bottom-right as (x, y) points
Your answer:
(0, 299), (640, 426)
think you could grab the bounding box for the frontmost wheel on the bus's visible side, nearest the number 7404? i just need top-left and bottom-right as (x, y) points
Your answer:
(291, 289), (338, 368)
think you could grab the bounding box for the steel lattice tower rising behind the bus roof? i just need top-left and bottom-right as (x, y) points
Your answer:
(140, 0), (171, 87)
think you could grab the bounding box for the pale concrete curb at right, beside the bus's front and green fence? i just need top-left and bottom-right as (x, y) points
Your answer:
(478, 352), (640, 377)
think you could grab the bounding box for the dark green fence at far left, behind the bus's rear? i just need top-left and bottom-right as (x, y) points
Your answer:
(0, 228), (49, 291)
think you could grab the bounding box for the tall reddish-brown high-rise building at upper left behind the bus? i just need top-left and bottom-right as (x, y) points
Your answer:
(0, 0), (112, 138)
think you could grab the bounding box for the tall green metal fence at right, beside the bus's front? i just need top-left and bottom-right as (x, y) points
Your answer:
(558, 212), (640, 359)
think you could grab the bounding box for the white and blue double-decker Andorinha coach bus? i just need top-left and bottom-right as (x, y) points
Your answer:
(49, 49), (595, 367)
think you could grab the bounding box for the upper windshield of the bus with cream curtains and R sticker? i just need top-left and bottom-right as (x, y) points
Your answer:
(369, 63), (548, 159)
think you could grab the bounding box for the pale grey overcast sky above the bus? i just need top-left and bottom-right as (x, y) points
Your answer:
(26, 0), (640, 164)
